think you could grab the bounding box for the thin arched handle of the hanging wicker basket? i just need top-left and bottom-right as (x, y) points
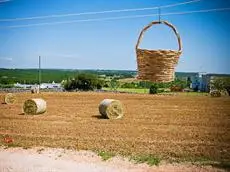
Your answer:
(136, 21), (182, 51)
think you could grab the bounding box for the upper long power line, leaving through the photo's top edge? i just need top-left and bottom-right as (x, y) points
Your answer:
(0, 0), (201, 22)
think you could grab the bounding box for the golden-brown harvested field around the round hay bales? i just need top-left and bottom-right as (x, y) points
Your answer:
(0, 92), (230, 167)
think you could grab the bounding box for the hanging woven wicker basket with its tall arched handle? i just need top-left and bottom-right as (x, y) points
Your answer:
(136, 21), (182, 82)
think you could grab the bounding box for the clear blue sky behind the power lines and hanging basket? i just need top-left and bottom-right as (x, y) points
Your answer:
(0, 0), (230, 74)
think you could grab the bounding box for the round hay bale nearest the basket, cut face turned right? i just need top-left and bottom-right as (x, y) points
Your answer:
(99, 99), (123, 119)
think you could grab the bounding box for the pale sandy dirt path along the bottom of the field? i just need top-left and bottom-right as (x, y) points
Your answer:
(0, 148), (224, 172)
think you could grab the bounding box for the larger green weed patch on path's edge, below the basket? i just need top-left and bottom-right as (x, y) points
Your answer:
(131, 155), (161, 166)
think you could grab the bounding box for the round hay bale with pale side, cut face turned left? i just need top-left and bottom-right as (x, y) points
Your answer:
(23, 99), (46, 115)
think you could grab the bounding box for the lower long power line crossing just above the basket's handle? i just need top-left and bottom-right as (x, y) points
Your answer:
(0, 7), (230, 29)
